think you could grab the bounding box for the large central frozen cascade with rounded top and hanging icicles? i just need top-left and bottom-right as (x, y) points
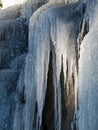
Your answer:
(24, 3), (82, 130)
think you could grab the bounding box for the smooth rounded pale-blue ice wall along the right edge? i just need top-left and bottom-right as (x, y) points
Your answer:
(79, 1), (98, 130)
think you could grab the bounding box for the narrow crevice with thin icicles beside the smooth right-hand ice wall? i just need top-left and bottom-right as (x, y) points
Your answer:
(73, 10), (89, 130)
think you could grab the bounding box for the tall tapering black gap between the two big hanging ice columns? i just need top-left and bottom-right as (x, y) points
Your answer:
(42, 52), (54, 130)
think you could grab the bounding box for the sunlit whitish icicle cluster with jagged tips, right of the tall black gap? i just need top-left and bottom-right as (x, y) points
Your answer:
(51, 3), (82, 130)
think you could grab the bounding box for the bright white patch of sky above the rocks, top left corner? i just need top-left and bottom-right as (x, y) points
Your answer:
(2, 0), (24, 8)
